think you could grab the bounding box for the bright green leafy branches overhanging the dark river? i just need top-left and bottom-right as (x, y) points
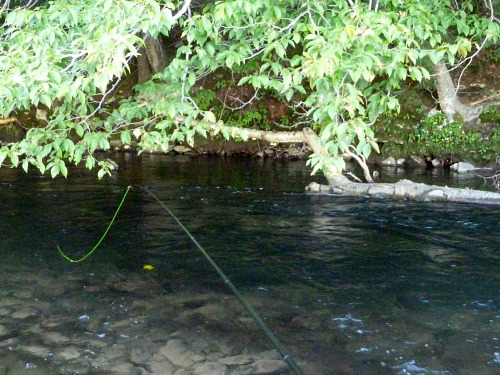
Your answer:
(0, 0), (500, 176)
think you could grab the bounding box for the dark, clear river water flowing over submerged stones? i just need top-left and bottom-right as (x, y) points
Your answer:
(0, 155), (500, 375)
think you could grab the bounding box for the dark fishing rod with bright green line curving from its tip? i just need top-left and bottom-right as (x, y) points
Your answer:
(57, 185), (304, 375)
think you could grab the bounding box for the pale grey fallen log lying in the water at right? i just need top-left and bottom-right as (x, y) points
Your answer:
(306, 175), (500, 205)
